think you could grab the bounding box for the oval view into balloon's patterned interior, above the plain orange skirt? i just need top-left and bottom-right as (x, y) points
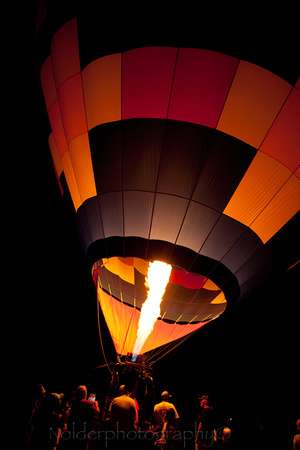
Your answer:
(92, 256), (227, 324)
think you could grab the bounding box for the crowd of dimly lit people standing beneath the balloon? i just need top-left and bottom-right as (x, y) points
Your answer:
(22, 384), (300, 450)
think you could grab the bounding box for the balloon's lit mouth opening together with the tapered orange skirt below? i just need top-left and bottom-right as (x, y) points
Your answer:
(92, 257), (227, 363)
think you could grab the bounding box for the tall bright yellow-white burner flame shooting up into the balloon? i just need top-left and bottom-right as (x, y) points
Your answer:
(133, 261), (172, 355)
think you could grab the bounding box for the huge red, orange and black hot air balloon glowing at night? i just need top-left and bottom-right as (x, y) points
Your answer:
(38, 2), (300, 368)
